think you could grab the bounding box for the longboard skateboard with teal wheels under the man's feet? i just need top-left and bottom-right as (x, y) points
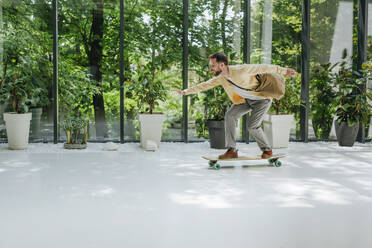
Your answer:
(202, 153), (287, 170)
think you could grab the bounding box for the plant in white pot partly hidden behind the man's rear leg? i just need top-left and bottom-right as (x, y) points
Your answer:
(263, 75), (301, 148)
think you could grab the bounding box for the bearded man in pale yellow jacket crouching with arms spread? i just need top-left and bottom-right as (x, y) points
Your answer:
(173, 52), (297, 159)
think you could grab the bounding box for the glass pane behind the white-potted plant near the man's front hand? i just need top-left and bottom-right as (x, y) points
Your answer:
(124, 0), (183, 141)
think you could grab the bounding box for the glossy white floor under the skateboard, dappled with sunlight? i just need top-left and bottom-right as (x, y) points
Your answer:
(0, 142), (372, 248)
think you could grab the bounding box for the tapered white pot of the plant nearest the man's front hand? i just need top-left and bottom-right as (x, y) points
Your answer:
(138, 114), (165, 150)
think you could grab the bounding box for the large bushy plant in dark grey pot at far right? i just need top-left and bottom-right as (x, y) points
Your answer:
(334, 57), (372, 146)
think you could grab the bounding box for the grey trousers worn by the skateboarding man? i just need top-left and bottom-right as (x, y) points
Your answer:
(225, 99), (271, 151)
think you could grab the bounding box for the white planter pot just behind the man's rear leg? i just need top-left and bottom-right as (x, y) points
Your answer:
(263, 115), (294, 148)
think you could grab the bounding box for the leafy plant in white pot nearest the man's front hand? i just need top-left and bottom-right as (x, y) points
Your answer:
(128, 62), (166, 150)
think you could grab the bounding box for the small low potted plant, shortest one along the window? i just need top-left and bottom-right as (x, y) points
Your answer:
(59, 114), (89, 149)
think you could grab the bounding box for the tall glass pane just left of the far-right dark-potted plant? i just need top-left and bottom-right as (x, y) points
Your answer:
(309, 0), (357, 140)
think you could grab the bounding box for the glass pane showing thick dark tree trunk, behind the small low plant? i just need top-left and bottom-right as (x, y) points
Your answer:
(58, 0), (120, 141)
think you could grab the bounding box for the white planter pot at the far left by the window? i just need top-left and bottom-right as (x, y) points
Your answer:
(4, 113), (32, 150)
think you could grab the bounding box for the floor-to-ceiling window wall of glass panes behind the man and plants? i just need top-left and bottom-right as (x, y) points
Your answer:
(0, 0), (372, 141)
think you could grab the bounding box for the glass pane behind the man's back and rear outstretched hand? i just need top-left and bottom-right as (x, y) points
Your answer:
(250, 0), (302, 139)
